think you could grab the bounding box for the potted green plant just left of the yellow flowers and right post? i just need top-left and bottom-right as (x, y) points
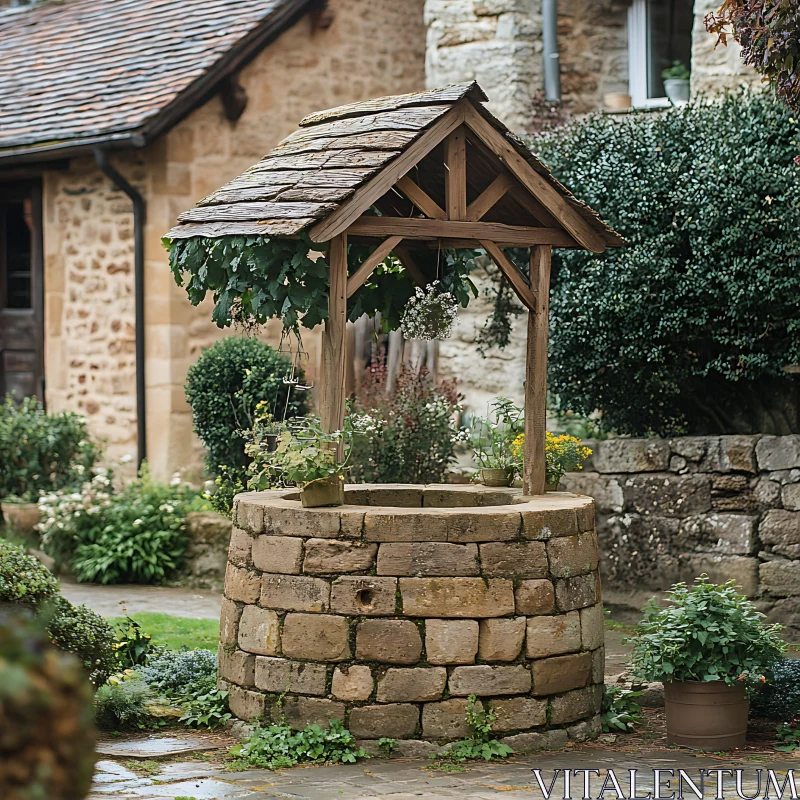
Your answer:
(472, 397), (525, 486)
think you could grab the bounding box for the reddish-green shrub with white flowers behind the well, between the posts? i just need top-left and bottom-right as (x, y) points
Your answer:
(350, 363), (464, 483)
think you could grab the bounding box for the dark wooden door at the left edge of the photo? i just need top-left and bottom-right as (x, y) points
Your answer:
(0, 181), (44, 401)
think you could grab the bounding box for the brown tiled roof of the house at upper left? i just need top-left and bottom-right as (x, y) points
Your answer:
(0, 0), (308, 157)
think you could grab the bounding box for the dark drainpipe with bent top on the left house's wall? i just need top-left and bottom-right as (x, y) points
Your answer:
(94, 148), (147, 467)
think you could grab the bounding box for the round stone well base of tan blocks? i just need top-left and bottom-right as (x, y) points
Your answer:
(220, 485), (603, 755)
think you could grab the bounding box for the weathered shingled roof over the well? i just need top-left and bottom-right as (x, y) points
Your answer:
(167, 82), (624, 247)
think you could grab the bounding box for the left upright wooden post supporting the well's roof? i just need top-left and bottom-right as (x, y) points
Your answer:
(320, 233), (347, 446)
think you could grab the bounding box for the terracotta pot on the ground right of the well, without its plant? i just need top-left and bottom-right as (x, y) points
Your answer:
(664, 681), (750, 750)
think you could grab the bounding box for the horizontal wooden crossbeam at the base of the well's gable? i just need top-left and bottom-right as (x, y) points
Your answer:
(347, 217), (576, 247)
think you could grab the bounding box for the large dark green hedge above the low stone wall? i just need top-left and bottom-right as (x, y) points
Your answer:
(532, 94), (800, 435)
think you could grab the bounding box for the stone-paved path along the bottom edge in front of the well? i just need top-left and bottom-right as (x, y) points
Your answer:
(89, 746), (800, 800)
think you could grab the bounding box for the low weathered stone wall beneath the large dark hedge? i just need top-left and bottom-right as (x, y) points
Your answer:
(561, 435), (800, 634)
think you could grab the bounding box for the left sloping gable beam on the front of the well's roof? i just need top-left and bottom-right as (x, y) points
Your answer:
(310, 101), (470, 242)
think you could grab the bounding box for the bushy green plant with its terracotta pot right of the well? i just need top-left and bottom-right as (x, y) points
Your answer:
(631, 575), (786, 750)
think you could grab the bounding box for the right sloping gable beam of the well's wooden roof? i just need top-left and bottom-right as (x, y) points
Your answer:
(464, 104), (606, 253)
